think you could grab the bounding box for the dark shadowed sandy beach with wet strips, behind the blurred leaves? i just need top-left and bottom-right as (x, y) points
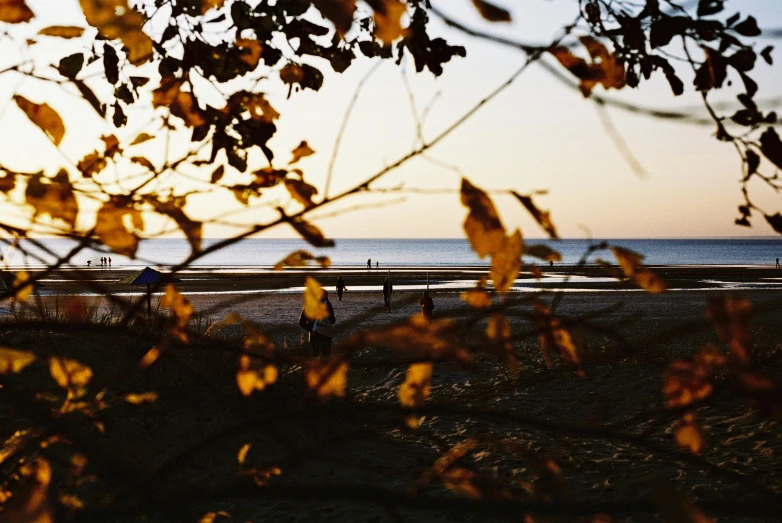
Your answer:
(3, 266), (782, 522)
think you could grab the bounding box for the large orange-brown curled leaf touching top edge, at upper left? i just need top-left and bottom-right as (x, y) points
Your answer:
(79, 0), (152, 65)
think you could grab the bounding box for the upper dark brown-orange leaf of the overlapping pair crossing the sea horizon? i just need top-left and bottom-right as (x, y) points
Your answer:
(461, 178), (505, 258)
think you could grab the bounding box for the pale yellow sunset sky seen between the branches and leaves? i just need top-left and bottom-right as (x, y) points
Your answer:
(0, 0), (782, 238)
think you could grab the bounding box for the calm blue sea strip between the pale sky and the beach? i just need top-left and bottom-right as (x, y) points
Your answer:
(0, 238), (782, 268)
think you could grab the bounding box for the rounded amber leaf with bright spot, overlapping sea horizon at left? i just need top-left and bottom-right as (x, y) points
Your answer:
(95, 196), (144, 258)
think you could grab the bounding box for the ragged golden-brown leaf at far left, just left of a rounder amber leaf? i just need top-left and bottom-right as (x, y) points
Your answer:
(25, 169), (79, 229)
